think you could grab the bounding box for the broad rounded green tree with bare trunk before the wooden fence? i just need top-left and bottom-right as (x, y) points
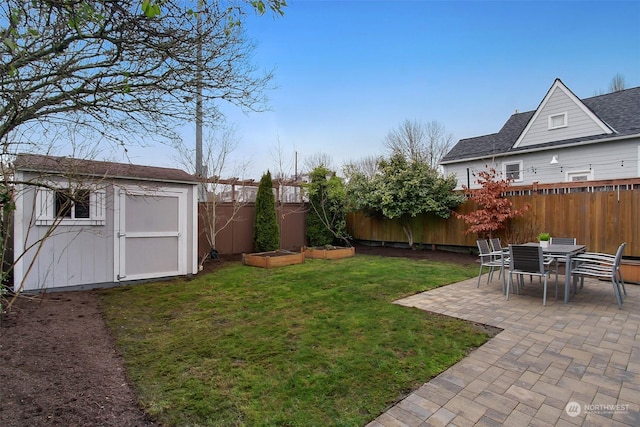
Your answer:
(345, 153), (465, 248)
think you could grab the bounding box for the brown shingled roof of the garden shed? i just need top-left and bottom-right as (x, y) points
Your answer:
(14, 154), (198, 183)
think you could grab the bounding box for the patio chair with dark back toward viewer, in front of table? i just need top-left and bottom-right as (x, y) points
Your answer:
(506, 245), (558, 305)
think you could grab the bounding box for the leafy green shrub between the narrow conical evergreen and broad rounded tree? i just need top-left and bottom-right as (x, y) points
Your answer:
(305, 165), (351, 246)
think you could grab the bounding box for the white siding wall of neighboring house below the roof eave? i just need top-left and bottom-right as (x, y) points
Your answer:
(443, 139), (640, 189)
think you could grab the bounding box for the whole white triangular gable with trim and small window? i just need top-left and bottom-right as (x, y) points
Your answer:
(514, 79), (613, 148)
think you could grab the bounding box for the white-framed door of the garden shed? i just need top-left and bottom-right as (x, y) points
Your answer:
(114, 187), (187, 281)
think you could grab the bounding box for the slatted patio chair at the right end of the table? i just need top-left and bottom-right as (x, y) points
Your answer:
(571, 242), (627, 308)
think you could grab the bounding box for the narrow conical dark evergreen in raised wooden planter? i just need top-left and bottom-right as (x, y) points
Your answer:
(253, 171), (280, 252)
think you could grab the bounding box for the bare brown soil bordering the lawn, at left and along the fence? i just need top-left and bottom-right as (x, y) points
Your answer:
(0, 245), (476, 427)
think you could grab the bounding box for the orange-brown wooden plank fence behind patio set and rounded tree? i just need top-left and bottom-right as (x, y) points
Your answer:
(347, 178), (640, 257)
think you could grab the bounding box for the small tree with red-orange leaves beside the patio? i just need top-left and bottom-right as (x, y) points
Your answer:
(455, 168), (529, 238)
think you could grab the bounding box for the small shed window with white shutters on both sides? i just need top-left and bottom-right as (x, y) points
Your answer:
(36, 188), (106, 225)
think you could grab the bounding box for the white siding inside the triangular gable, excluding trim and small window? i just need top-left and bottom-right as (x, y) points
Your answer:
(519, 87), (605, 147)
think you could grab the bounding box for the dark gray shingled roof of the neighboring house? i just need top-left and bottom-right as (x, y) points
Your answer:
(441, 82), (640, 164)
